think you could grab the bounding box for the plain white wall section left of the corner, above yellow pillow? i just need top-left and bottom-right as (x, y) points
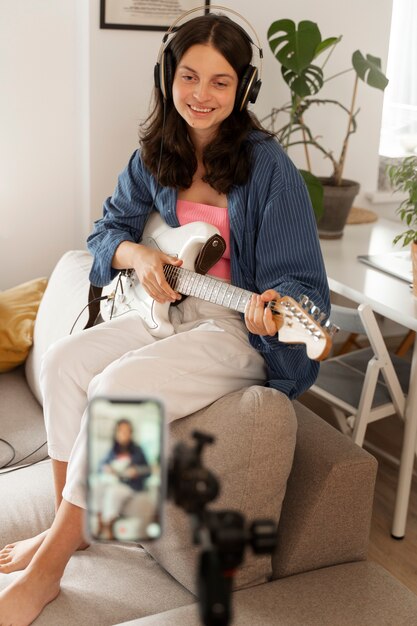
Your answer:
(0, 0), (75, 288)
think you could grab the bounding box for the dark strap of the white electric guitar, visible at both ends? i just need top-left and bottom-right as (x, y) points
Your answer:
(84, 235), (226, 330)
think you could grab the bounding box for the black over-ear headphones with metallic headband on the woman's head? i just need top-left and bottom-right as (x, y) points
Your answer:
(154, 4), (263, 111)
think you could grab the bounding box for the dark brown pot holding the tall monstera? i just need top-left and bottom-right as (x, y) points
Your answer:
(317, 178), (359, 239)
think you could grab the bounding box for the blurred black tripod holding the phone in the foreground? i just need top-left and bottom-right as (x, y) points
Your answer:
(168, 431), (277, 626)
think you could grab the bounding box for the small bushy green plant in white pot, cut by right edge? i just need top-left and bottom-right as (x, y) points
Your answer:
(388, 156), (417, 296)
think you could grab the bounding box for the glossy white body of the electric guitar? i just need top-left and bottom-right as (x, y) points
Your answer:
(101, 211), (219, 338)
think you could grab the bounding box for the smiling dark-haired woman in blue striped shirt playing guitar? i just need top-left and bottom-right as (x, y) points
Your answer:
(0, 14), (329, 624)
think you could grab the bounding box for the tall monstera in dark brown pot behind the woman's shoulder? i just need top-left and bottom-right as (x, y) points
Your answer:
(262, 19), (388, 238)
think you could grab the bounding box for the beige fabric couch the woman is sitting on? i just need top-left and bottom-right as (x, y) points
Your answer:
(0, 251), (417, 626)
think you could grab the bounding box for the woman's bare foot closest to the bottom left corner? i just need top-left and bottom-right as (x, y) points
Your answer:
(0, 573), (60, 626)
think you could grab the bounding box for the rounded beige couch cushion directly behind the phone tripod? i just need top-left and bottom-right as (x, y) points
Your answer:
(144, 386), (297, 593)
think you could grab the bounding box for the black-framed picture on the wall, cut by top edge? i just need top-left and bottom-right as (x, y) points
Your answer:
(100, 0), (210, 31)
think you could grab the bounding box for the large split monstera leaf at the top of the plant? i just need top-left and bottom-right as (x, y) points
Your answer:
(268, 19), (321, 73)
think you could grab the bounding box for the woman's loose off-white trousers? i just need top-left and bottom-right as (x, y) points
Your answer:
(41, 297), (266, 508)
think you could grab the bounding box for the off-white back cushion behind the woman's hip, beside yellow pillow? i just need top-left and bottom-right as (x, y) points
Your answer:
(26, 250), (92, 404)
